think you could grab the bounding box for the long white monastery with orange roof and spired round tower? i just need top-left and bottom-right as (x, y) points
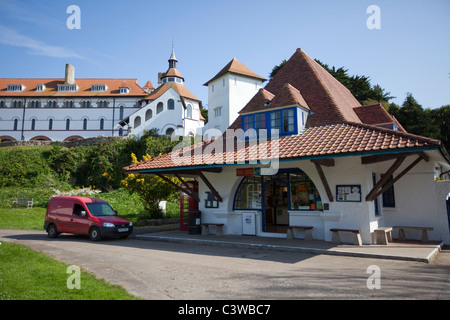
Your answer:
(0, 49), (204, 141)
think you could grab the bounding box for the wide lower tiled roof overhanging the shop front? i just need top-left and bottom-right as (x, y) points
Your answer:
(124, 123), (441, 172)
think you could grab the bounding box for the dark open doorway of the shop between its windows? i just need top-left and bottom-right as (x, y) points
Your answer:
(263, 180), (289, 233)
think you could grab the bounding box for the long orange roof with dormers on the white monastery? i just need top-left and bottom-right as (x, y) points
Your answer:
(0, 78), (147, 98)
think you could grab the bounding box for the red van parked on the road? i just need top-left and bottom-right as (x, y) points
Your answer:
(44, 197), (133, 241)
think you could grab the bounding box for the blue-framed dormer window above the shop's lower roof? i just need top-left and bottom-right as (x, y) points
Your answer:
(241, 107), (298, 136)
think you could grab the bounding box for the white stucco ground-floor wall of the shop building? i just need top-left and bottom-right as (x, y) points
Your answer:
(199, 151), (450, 244)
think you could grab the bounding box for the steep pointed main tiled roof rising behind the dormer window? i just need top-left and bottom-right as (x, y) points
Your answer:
(264, 49), (361, 127)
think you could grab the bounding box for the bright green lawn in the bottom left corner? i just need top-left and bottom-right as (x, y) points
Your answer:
(0, 242), (139, 300)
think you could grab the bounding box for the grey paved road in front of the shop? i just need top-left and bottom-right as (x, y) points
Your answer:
(0, 230), (450, 299)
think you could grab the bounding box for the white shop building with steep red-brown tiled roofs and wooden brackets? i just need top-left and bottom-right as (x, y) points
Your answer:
(124, 49), (450, 244)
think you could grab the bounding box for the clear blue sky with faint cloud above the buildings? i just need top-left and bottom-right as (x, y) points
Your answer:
(0, 0), (450, 108)
